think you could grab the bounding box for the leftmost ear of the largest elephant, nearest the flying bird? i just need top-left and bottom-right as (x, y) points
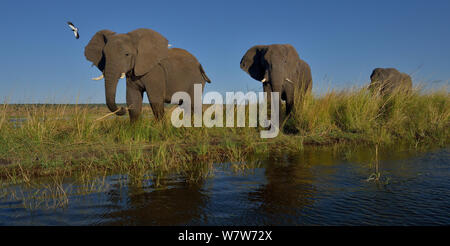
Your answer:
(84, 30), (115, 71)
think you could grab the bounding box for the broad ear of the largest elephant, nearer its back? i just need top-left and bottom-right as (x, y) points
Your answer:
(128, 28), (169, 76)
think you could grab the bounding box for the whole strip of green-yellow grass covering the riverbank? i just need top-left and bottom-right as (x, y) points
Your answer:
(0, 85), (450, 183)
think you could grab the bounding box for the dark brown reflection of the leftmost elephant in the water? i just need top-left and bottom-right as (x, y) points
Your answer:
(100, 179), (208, 225)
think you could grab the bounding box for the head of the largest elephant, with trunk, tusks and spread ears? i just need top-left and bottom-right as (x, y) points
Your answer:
(84, 28), (168, 115)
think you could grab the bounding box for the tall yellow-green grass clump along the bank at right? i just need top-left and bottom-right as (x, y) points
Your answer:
(292, 85), (450, 144)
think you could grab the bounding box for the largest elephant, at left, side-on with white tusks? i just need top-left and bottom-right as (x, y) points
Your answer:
(84, 28), (211, 122)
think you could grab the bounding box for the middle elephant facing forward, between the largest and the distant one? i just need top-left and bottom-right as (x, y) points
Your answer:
(241, 44), (312, 123)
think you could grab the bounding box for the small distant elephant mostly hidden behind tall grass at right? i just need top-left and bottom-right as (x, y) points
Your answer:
(369, 68), (412, 95)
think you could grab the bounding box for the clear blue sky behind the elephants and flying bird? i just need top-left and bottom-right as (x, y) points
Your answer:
(0, 0), (450, 103)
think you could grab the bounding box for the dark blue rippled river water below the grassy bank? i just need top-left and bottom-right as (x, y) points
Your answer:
(0, 147), (450, 225)
